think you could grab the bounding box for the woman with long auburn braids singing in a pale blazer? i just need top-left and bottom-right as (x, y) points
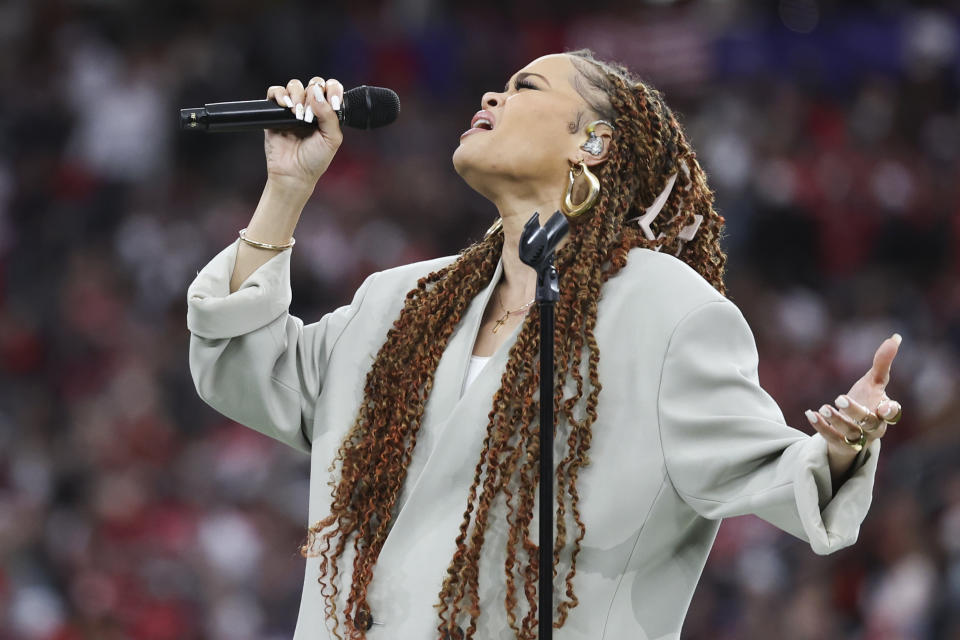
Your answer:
(187, 51), (900, 640)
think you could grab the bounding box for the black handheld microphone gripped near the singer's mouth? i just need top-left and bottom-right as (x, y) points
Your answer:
(180, 85), (400, 133)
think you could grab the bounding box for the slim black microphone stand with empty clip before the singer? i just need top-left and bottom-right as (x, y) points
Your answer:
(520, 211), (570, 640)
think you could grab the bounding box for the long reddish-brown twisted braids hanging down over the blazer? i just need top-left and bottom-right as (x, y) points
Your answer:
(300, 49), (726, 640)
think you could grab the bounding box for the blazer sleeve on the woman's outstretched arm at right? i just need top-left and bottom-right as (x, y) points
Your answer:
(658, 299), (880, 555)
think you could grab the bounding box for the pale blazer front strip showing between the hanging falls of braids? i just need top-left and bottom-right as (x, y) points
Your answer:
(368, 263), (523, 634)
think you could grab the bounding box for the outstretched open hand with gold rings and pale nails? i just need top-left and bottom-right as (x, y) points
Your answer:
(805, 333), (901, 480)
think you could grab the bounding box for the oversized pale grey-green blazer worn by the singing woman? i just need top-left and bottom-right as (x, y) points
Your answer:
(187, 240), (880, 640)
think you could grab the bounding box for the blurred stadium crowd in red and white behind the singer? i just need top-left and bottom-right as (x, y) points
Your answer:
(0, 0), (960, 640)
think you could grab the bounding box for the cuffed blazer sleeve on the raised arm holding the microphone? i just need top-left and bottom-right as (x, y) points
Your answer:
(187, 240), (376, 452)
